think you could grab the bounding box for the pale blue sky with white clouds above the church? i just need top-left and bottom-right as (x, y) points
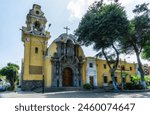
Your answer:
(0, 0), (150, 68)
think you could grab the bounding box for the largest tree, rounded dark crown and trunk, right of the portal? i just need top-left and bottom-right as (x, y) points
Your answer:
(75, 0), (128, 90)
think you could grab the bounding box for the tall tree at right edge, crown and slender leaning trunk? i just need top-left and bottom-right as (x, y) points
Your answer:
(120, 3), (150, 88)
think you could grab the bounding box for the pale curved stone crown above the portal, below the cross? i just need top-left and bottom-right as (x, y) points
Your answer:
(54, 33), (79, 45)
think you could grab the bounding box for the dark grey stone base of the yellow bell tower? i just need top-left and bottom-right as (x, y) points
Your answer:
(21, 80), (43, 91)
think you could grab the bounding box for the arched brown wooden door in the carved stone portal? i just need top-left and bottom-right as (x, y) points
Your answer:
(62, 67), (73, 87)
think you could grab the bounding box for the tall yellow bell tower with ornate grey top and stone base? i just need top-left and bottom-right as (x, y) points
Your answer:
(21, 4), (50, 90)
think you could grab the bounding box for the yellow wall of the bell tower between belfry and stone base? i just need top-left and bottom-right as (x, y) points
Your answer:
(22, 33), (48, 80)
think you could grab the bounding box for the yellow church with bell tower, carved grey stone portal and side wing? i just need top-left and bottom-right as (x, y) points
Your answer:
(21, 4), (136, 90)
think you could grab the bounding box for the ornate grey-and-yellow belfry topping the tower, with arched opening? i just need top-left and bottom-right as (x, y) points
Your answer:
(22, 4), (47, 36)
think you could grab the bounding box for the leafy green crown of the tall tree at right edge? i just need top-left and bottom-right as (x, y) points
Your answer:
(120, 4), (150, 53)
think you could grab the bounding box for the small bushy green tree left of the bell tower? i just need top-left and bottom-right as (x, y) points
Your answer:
(0, 63), (19, 90)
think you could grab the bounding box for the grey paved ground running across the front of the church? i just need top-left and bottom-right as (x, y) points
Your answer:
(0, 91), (150, 98)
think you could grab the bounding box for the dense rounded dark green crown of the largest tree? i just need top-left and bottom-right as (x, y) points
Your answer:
(75, 4), (128, 47)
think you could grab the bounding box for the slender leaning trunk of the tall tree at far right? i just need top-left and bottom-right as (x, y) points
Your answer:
(136, 51), (146, 89)
